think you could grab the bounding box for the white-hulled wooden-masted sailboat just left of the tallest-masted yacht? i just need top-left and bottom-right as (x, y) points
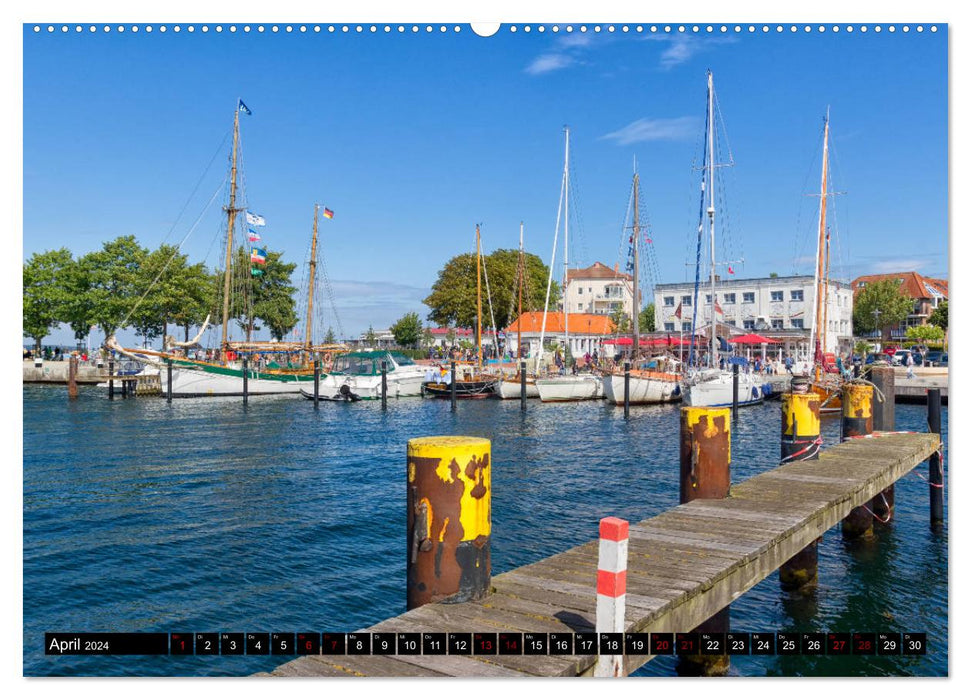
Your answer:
(603, 168), (681, 405)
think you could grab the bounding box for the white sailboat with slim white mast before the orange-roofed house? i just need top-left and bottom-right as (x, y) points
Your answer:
(536, 127), (604, 402)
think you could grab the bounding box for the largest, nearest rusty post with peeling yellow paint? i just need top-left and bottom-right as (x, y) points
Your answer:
(407, 436), (492, 610)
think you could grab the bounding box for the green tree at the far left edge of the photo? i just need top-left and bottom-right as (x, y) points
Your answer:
(23, 248), (74, 351)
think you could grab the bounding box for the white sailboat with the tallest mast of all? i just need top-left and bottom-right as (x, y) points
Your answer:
(682, 71), (763, 406)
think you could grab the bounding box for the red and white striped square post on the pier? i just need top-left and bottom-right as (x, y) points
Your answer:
(593, 517), (630, 678)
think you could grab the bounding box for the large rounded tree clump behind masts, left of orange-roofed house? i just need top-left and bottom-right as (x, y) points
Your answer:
(424, 249), (560, 329)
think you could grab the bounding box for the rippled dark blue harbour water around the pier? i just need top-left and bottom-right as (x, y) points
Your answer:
(23, 386), (948, 676)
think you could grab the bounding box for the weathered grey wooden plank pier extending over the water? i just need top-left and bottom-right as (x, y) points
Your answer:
(260, 433), (940, 677)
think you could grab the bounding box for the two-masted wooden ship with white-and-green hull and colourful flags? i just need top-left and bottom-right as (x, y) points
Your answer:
(105, 100), (344, 398)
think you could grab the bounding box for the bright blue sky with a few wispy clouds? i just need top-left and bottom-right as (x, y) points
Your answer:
(23, 24), (948, 342)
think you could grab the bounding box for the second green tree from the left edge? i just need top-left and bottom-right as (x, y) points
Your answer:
(78, 236), (148, 337)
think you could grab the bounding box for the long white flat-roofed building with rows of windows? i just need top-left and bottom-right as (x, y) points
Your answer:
(654, 275), (853, 354)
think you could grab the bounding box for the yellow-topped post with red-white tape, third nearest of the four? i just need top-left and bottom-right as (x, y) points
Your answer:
(779, 392), (821, 591)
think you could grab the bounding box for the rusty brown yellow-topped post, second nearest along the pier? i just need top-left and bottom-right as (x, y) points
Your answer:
(677, 407), (731, 676)
